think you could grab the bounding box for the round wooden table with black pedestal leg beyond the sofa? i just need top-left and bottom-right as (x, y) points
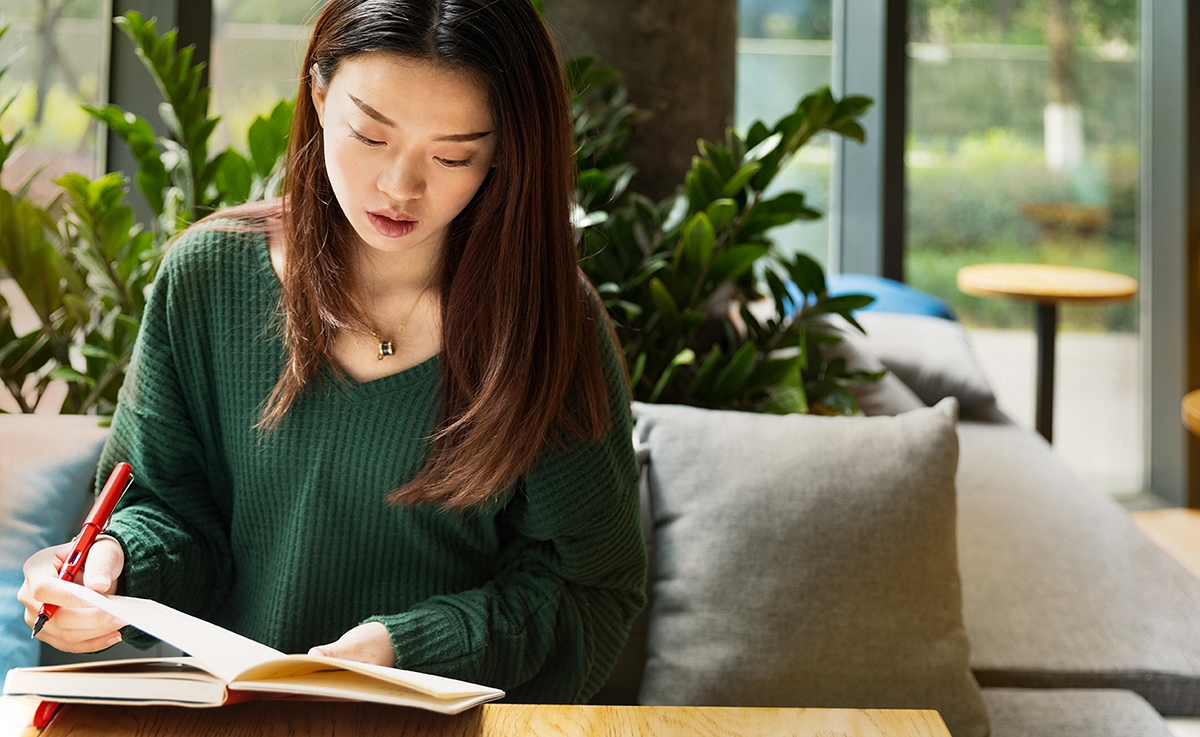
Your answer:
(958, 264), (1138, 442)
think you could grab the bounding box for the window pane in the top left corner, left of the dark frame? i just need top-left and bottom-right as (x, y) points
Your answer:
(0, 0), (108, 204)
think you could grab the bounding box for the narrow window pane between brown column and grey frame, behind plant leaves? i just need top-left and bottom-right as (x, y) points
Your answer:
(734, 0), (833, 265)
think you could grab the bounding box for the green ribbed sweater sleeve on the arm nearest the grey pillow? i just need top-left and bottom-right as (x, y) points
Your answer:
(367, 324), (647, 703)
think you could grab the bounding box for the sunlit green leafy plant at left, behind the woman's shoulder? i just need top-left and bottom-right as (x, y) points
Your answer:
(0, 12), (292, 414)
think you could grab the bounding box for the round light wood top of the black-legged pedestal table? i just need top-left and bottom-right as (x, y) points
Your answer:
(958, 264), (1138, 301)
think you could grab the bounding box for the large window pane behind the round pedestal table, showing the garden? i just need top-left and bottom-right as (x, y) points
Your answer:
(906, 0), (1142, 495)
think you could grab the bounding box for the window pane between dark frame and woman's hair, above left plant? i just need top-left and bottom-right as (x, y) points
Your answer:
(209, 0), (325, 152)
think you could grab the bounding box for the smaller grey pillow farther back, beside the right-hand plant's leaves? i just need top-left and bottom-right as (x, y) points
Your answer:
(854, 310), (996, 418)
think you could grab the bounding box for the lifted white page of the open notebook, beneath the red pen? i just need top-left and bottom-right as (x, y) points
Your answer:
(73, 586), (287, 683)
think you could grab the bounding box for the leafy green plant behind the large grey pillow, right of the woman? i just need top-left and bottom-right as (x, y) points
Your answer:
(568, 56), (882, 414)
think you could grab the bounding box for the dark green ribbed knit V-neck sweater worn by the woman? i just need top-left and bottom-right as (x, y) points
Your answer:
(100, 223), (646, 702)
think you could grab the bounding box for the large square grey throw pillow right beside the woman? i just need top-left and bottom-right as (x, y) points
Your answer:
(634, 400), (989, 737)
